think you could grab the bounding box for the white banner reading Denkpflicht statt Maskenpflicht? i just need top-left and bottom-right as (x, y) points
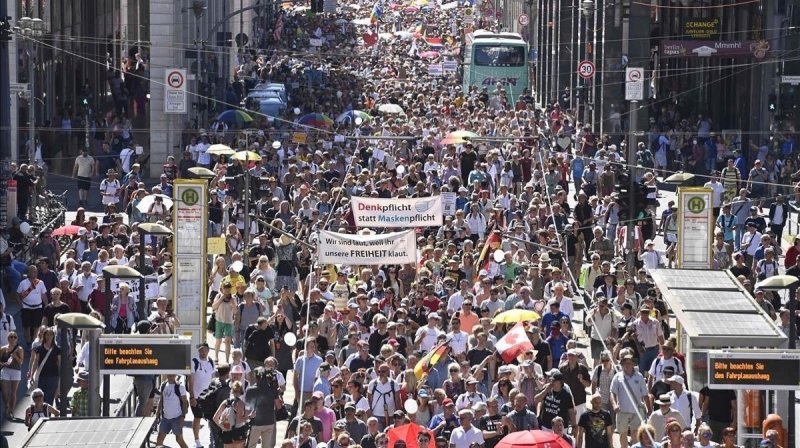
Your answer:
(350, 196), (443, 228)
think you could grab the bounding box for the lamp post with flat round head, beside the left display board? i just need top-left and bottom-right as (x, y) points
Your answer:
(56, 313), (105, 417)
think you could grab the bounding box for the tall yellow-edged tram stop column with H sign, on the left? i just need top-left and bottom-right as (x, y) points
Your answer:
(172, 180), (208, 345)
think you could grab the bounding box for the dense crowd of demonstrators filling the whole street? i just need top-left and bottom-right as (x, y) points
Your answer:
(0, 2), (800, 448)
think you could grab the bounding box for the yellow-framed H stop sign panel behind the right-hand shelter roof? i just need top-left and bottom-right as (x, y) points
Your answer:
(678, 188), (714, 269)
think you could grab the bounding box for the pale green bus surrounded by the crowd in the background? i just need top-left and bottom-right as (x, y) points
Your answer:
(463, 30), (530, 104)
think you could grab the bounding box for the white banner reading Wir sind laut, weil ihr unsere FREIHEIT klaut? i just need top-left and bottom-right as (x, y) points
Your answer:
(318, 230), (417, 266)
